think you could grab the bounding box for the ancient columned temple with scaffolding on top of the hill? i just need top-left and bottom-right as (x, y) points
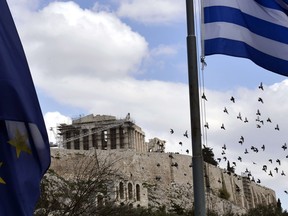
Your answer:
(58, 113), (148, 152)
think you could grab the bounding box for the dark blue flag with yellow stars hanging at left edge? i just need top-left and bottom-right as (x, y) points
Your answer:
(0, 0), (50, 216)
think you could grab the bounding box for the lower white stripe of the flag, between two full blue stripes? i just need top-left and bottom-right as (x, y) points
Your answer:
(205, 22), (288, 61)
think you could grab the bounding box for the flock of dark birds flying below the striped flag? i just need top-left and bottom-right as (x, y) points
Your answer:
(170, 82), (288, 194)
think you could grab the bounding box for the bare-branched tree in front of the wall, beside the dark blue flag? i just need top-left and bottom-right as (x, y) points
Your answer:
(35, 150), (121, 216)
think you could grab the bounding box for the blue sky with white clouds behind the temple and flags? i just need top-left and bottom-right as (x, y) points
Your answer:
(7, 0), (288, 209)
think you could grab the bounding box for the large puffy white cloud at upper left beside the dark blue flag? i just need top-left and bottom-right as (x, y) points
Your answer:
(10, 2), (148, 87)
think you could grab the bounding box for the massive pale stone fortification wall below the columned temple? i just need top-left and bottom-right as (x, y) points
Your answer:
(51, 149), (276, 213)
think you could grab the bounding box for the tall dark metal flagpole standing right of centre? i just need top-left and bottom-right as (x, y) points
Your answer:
(186, 0), (206, 216)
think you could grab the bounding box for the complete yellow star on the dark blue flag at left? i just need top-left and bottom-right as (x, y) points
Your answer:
(8, 129), (32, 158)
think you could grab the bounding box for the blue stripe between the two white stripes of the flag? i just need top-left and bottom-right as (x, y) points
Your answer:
(204, 6), (288, 44)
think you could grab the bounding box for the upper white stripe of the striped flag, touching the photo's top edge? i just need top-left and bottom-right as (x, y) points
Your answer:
(204, 0), (288, 28)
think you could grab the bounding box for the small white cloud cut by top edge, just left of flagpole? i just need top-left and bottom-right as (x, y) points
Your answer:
(117, 0), (186, 24)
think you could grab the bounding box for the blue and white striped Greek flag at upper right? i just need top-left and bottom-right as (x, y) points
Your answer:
(203, 0), (288, 76)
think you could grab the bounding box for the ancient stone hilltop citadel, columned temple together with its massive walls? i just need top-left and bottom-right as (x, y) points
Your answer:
(51, 114), (276, 214)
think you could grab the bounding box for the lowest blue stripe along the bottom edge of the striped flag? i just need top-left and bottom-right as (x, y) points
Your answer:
(205, 38), (288, 76)
